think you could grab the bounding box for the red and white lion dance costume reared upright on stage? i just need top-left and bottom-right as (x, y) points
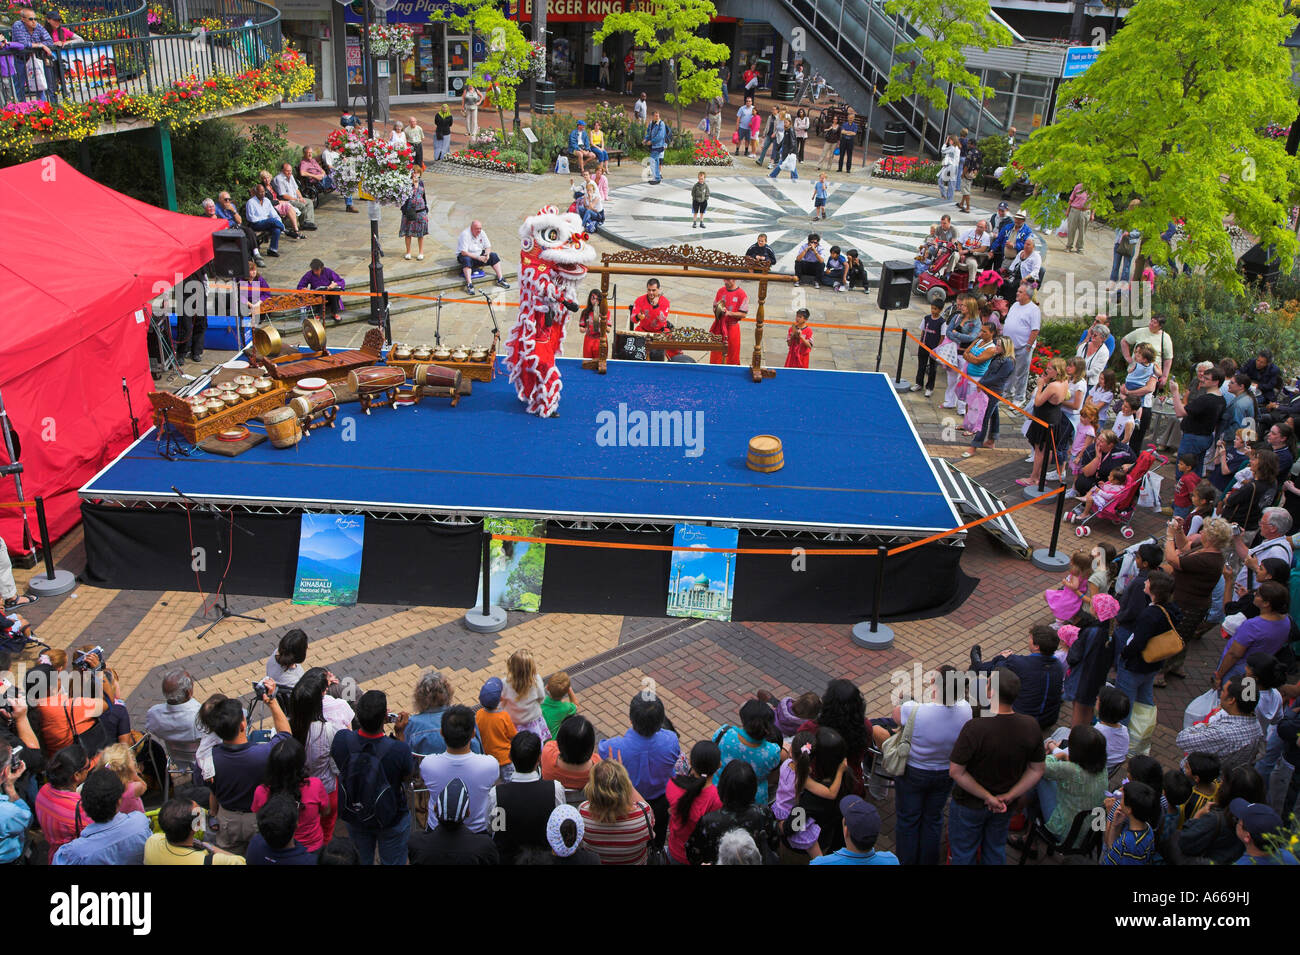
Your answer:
(506, 205), (595, 417)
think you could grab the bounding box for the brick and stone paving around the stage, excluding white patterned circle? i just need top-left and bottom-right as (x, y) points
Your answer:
(16, 103), (1219, 846)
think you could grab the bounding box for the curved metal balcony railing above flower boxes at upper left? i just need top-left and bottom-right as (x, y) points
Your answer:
(4, 0), (283, 103)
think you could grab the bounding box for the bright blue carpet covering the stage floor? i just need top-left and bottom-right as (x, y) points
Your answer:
(83, 359), (959, 534)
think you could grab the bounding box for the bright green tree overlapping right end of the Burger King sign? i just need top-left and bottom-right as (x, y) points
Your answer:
(592, 0), (731, 129)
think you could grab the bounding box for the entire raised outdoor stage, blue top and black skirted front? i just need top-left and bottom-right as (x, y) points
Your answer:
(73, 359), (962, 621)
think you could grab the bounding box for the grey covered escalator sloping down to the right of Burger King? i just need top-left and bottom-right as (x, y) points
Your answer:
(716, 0), (1019, 156)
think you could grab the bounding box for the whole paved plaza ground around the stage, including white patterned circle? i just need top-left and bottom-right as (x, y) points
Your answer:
(17, 95), (1190, 846)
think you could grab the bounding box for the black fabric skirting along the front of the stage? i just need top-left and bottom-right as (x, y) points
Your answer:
(82, 503), (970, 624)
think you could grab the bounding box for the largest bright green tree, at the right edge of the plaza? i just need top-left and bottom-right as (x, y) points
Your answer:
(1004, 0), (1300, 288)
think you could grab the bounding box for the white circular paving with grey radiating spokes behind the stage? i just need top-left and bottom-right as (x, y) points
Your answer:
(601, 178), (991, 275)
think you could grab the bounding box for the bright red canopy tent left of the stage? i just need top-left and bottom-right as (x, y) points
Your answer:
(0, 157), (225, 554)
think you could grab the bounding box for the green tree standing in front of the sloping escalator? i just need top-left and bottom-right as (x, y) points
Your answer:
(880, 0), (1013, 155)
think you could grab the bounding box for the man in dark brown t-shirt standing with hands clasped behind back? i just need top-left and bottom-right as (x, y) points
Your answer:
(948, 668), (1047, 865)
